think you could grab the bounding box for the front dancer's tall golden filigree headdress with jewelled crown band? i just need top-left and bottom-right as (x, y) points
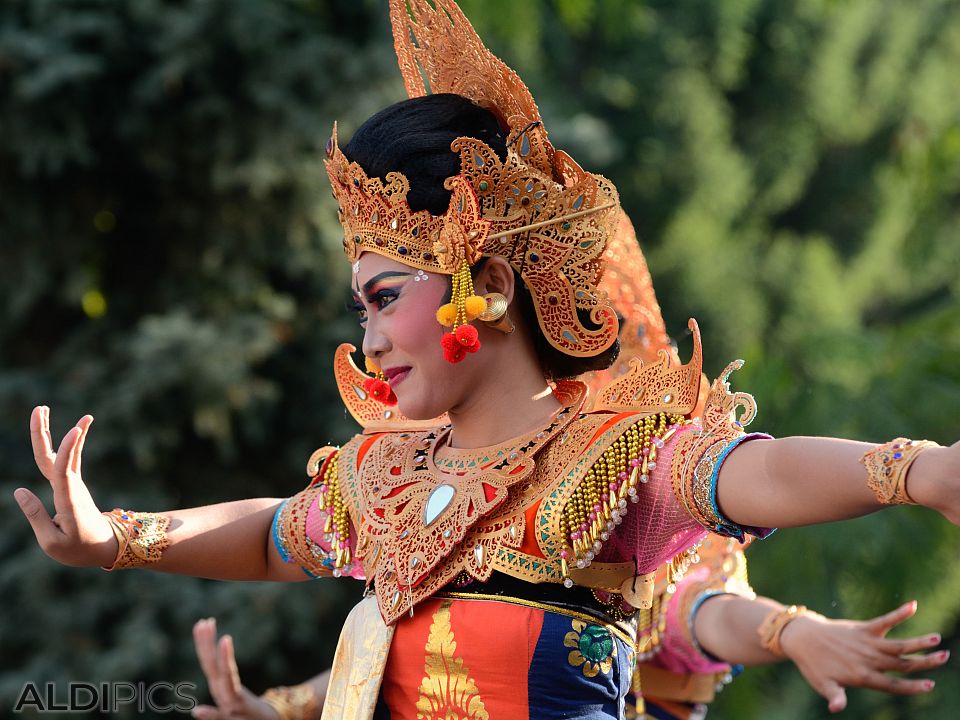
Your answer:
(326, 0), (619, 357)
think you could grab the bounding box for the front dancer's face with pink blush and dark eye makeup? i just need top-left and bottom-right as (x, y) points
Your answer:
(352, 252), (480, 420)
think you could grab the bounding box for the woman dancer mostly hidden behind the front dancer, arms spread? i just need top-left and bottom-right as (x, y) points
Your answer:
(184, 211), (949, 720)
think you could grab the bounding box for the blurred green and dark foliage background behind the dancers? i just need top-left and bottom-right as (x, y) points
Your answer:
(0, 0), (960, 720)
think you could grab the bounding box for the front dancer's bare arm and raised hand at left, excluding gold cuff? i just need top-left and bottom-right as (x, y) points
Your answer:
(14, 407), (306, 580)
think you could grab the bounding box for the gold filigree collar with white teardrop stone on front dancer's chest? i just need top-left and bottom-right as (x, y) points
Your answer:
(341, 382), (586, 624)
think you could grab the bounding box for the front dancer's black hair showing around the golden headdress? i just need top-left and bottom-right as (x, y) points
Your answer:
(343, 93), (620, 380)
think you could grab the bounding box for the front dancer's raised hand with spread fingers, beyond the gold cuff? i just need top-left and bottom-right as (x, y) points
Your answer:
(14, 406), (117, 566)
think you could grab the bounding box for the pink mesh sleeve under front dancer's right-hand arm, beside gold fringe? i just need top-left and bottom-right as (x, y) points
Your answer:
(597, 426), (707, 574)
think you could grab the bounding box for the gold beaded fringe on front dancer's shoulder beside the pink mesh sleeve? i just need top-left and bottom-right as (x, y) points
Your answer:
(560, 413), (683, 587)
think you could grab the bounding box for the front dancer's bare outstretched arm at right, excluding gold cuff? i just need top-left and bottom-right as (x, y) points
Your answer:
(717, 437), (960, 527)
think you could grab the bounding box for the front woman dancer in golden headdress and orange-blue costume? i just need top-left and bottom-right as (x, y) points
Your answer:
(16, 0), (960, 718)
